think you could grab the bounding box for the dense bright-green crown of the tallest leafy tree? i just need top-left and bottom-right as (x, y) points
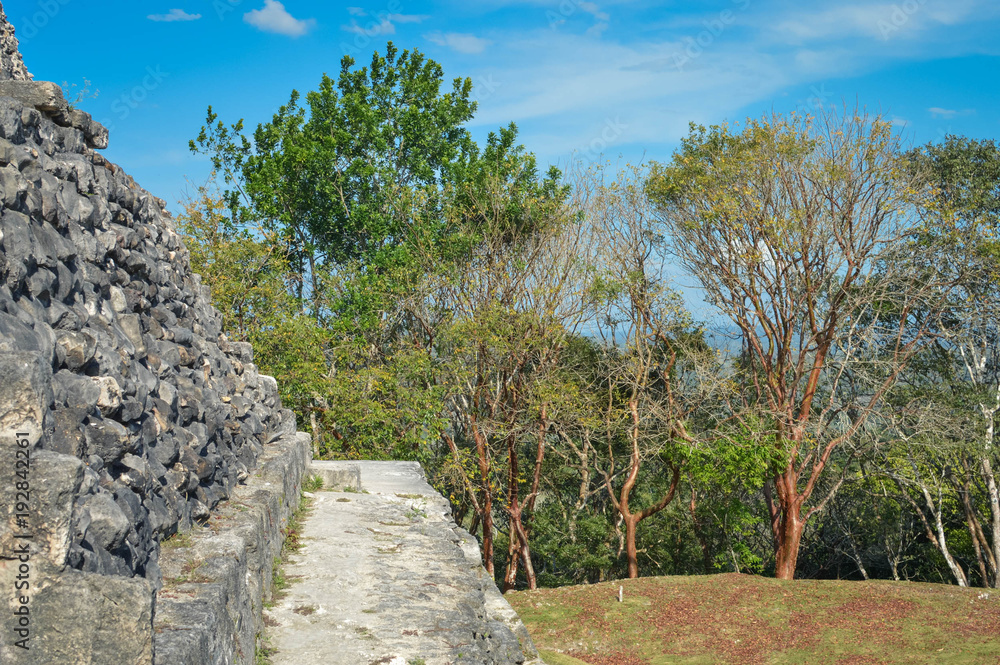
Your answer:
(191, 42), (476, 323)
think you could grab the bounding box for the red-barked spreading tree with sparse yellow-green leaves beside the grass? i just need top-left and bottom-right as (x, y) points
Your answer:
(648, 111), (952, 579)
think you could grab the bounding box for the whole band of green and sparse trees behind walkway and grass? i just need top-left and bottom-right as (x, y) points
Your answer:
(181, 44), (1000, 589)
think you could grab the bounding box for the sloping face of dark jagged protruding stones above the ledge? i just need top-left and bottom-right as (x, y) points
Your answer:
(0, 72), (295, 585)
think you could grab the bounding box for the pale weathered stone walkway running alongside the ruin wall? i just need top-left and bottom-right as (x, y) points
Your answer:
(265, 462), (541, 665)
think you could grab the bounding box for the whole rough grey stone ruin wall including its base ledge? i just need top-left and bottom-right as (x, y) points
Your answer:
(0, 5), (530, 665)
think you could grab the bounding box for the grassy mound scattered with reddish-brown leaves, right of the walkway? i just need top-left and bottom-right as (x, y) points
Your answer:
(506, 574), (1000, 665)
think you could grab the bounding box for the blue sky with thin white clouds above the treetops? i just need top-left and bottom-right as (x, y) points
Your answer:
(4, 0), (1000, 211)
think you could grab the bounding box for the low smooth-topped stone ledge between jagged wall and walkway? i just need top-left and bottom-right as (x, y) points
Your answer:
(153, 432), (311, 665)
